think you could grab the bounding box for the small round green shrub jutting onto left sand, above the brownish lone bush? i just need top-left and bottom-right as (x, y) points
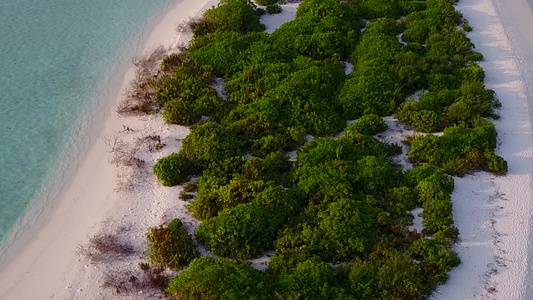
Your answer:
(153, 153), (193, 186)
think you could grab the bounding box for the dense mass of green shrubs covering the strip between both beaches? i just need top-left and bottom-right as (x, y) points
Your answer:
(143, 0), (507, 299)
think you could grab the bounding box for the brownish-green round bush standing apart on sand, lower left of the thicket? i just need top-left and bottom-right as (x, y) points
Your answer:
(146, 219), (200, 270)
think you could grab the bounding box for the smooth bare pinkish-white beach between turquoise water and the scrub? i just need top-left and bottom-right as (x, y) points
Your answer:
(0, 0), (217, 299)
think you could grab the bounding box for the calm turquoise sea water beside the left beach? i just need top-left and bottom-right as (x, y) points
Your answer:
(0, 0), (171, 241)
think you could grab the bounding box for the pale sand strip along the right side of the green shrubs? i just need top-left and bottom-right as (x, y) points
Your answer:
(433, 0), (533, 299)
